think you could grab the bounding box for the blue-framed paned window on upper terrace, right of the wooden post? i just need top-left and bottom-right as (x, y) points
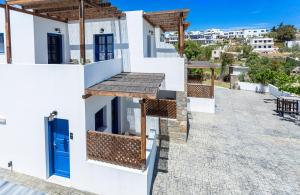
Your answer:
(94, 34), (114, 62)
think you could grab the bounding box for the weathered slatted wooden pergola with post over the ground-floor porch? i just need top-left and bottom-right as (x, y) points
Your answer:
(83, 72), (165, 160)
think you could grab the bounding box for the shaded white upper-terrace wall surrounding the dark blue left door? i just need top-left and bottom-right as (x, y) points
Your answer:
(33, 16), (70, 64)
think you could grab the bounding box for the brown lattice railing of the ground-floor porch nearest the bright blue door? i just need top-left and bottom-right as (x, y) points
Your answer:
(87, 131), (145, 169)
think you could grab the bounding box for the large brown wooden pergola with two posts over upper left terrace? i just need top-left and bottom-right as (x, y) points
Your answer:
(0, 0), (125, 64)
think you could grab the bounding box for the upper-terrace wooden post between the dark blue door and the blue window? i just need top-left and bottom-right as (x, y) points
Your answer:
(79, 0), (86, 65)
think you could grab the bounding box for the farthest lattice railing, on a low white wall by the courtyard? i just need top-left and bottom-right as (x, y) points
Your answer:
(187, 83), (214, 98)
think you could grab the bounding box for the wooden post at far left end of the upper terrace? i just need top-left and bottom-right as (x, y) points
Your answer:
(5, 4), (12, 64)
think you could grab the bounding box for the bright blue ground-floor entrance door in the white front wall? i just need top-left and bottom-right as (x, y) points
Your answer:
(49, 119), (70, 178)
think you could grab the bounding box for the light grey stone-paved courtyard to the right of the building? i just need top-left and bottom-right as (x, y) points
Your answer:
(153, 89), (300, 195)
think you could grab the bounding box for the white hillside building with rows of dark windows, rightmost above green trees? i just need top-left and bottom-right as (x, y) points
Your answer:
(250, 38), (275, 53)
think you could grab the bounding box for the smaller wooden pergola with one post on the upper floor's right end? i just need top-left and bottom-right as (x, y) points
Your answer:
(144, 9), (190, 57)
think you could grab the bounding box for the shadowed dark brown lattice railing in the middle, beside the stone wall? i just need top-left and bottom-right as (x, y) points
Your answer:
(145, 99), (177, 119)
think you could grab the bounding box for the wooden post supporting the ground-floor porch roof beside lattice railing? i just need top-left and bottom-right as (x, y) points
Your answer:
(140, 99), (146, 163)
